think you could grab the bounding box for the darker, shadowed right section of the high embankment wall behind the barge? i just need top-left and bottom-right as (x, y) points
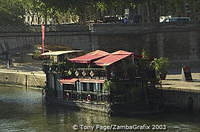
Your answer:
(94, 24), (200, 71)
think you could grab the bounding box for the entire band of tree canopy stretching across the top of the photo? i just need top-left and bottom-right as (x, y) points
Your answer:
(0, 0), (200, 25)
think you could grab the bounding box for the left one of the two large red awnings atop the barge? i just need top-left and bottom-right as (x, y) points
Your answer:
(69, 50), (109, 63)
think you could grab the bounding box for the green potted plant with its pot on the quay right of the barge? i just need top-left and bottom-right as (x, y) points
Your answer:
(151, 57), (169, 80)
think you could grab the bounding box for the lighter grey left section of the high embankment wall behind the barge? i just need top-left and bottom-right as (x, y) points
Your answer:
(0, 32), (91, 54)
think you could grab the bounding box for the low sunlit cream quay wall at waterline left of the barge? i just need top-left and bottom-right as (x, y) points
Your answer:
(0, 72), (46, 88)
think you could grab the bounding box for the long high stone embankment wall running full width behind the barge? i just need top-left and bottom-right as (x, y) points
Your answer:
(0, 24), (200, 67)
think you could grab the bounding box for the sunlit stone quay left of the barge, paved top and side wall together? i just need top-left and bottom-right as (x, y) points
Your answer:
(0, 64), (46, 87)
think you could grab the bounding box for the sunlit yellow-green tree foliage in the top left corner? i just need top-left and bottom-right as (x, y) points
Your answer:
(0, 0), (77, 26)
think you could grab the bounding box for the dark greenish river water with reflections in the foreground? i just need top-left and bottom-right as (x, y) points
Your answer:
(0, 85), (200, 132)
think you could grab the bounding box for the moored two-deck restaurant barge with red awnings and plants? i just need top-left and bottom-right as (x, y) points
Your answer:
(42, 50), (162, 113)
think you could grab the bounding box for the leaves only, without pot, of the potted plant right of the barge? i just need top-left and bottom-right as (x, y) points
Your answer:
(151, 57), (169, 73)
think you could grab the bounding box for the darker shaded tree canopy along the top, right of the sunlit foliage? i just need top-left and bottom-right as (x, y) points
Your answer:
(40, 0), (200, 23)
